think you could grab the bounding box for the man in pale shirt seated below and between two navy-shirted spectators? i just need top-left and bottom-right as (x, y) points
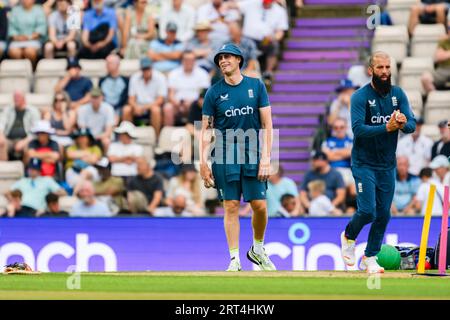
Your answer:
(77, 88), (114, 151)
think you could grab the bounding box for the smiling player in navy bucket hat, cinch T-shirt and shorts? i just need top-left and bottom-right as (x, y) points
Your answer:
(200, 43), (276, 271)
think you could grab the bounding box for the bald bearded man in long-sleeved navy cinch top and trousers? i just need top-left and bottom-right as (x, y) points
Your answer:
(341, 51), (416, 273)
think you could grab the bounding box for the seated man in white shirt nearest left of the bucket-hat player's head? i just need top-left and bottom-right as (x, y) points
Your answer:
(164, 51), (211, 126)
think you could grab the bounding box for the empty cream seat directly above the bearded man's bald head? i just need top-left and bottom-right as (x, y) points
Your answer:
(372, 25), (409, 63)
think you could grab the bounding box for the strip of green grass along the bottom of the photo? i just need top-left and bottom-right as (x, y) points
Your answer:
(0, 271), (450, 300)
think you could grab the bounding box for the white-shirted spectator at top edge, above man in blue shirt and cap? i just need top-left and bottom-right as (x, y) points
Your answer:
(159, 0), (195, 42)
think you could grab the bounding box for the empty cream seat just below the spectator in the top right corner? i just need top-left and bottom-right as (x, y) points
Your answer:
(411, 24), (446, 57)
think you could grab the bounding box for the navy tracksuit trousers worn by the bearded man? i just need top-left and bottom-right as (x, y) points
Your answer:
(345, 167), (396, 257)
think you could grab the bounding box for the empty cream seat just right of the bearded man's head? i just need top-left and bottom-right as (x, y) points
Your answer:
(399, 56), (434, 94)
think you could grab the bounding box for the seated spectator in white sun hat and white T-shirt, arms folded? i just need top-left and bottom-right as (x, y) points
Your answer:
(108, 121), (144, 178)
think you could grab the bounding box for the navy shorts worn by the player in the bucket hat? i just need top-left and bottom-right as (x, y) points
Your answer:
(212, 163), (267, 202)
